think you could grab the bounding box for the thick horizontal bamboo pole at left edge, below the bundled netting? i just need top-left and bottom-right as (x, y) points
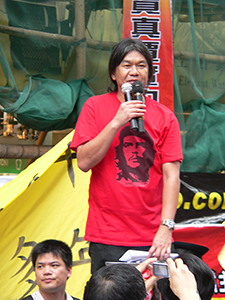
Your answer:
(0, 144), (52, 159)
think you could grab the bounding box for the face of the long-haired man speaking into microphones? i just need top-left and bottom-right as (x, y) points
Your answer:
(111, 51), (149, 99)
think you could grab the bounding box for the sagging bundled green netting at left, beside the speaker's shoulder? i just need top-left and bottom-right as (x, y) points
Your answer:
(0, 76), (94, 131)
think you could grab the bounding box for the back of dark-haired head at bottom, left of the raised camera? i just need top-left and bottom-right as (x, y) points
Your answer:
(83, 264), (147, 300)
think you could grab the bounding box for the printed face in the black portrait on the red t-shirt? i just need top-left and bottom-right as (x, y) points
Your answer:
(123, 136), (146, 168)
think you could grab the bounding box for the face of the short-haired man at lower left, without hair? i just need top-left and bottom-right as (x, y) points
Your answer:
(35, 253), (72, 293)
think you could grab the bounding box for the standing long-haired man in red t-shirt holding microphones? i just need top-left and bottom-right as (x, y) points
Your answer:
(70, 38), (183, 273)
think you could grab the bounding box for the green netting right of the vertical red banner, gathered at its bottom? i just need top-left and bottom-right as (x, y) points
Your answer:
(172, 0), (225, 173)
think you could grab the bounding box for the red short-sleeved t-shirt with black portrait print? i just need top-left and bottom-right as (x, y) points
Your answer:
(70, 92), (182, 246)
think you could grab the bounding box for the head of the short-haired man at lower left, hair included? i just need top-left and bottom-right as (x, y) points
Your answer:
(31, 239), (72, 298)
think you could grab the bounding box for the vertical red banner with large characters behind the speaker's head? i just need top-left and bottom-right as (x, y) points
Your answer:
(123, 0), (173, 110)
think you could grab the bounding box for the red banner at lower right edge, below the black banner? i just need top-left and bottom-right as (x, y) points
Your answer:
(174, 224), (225, 299)
